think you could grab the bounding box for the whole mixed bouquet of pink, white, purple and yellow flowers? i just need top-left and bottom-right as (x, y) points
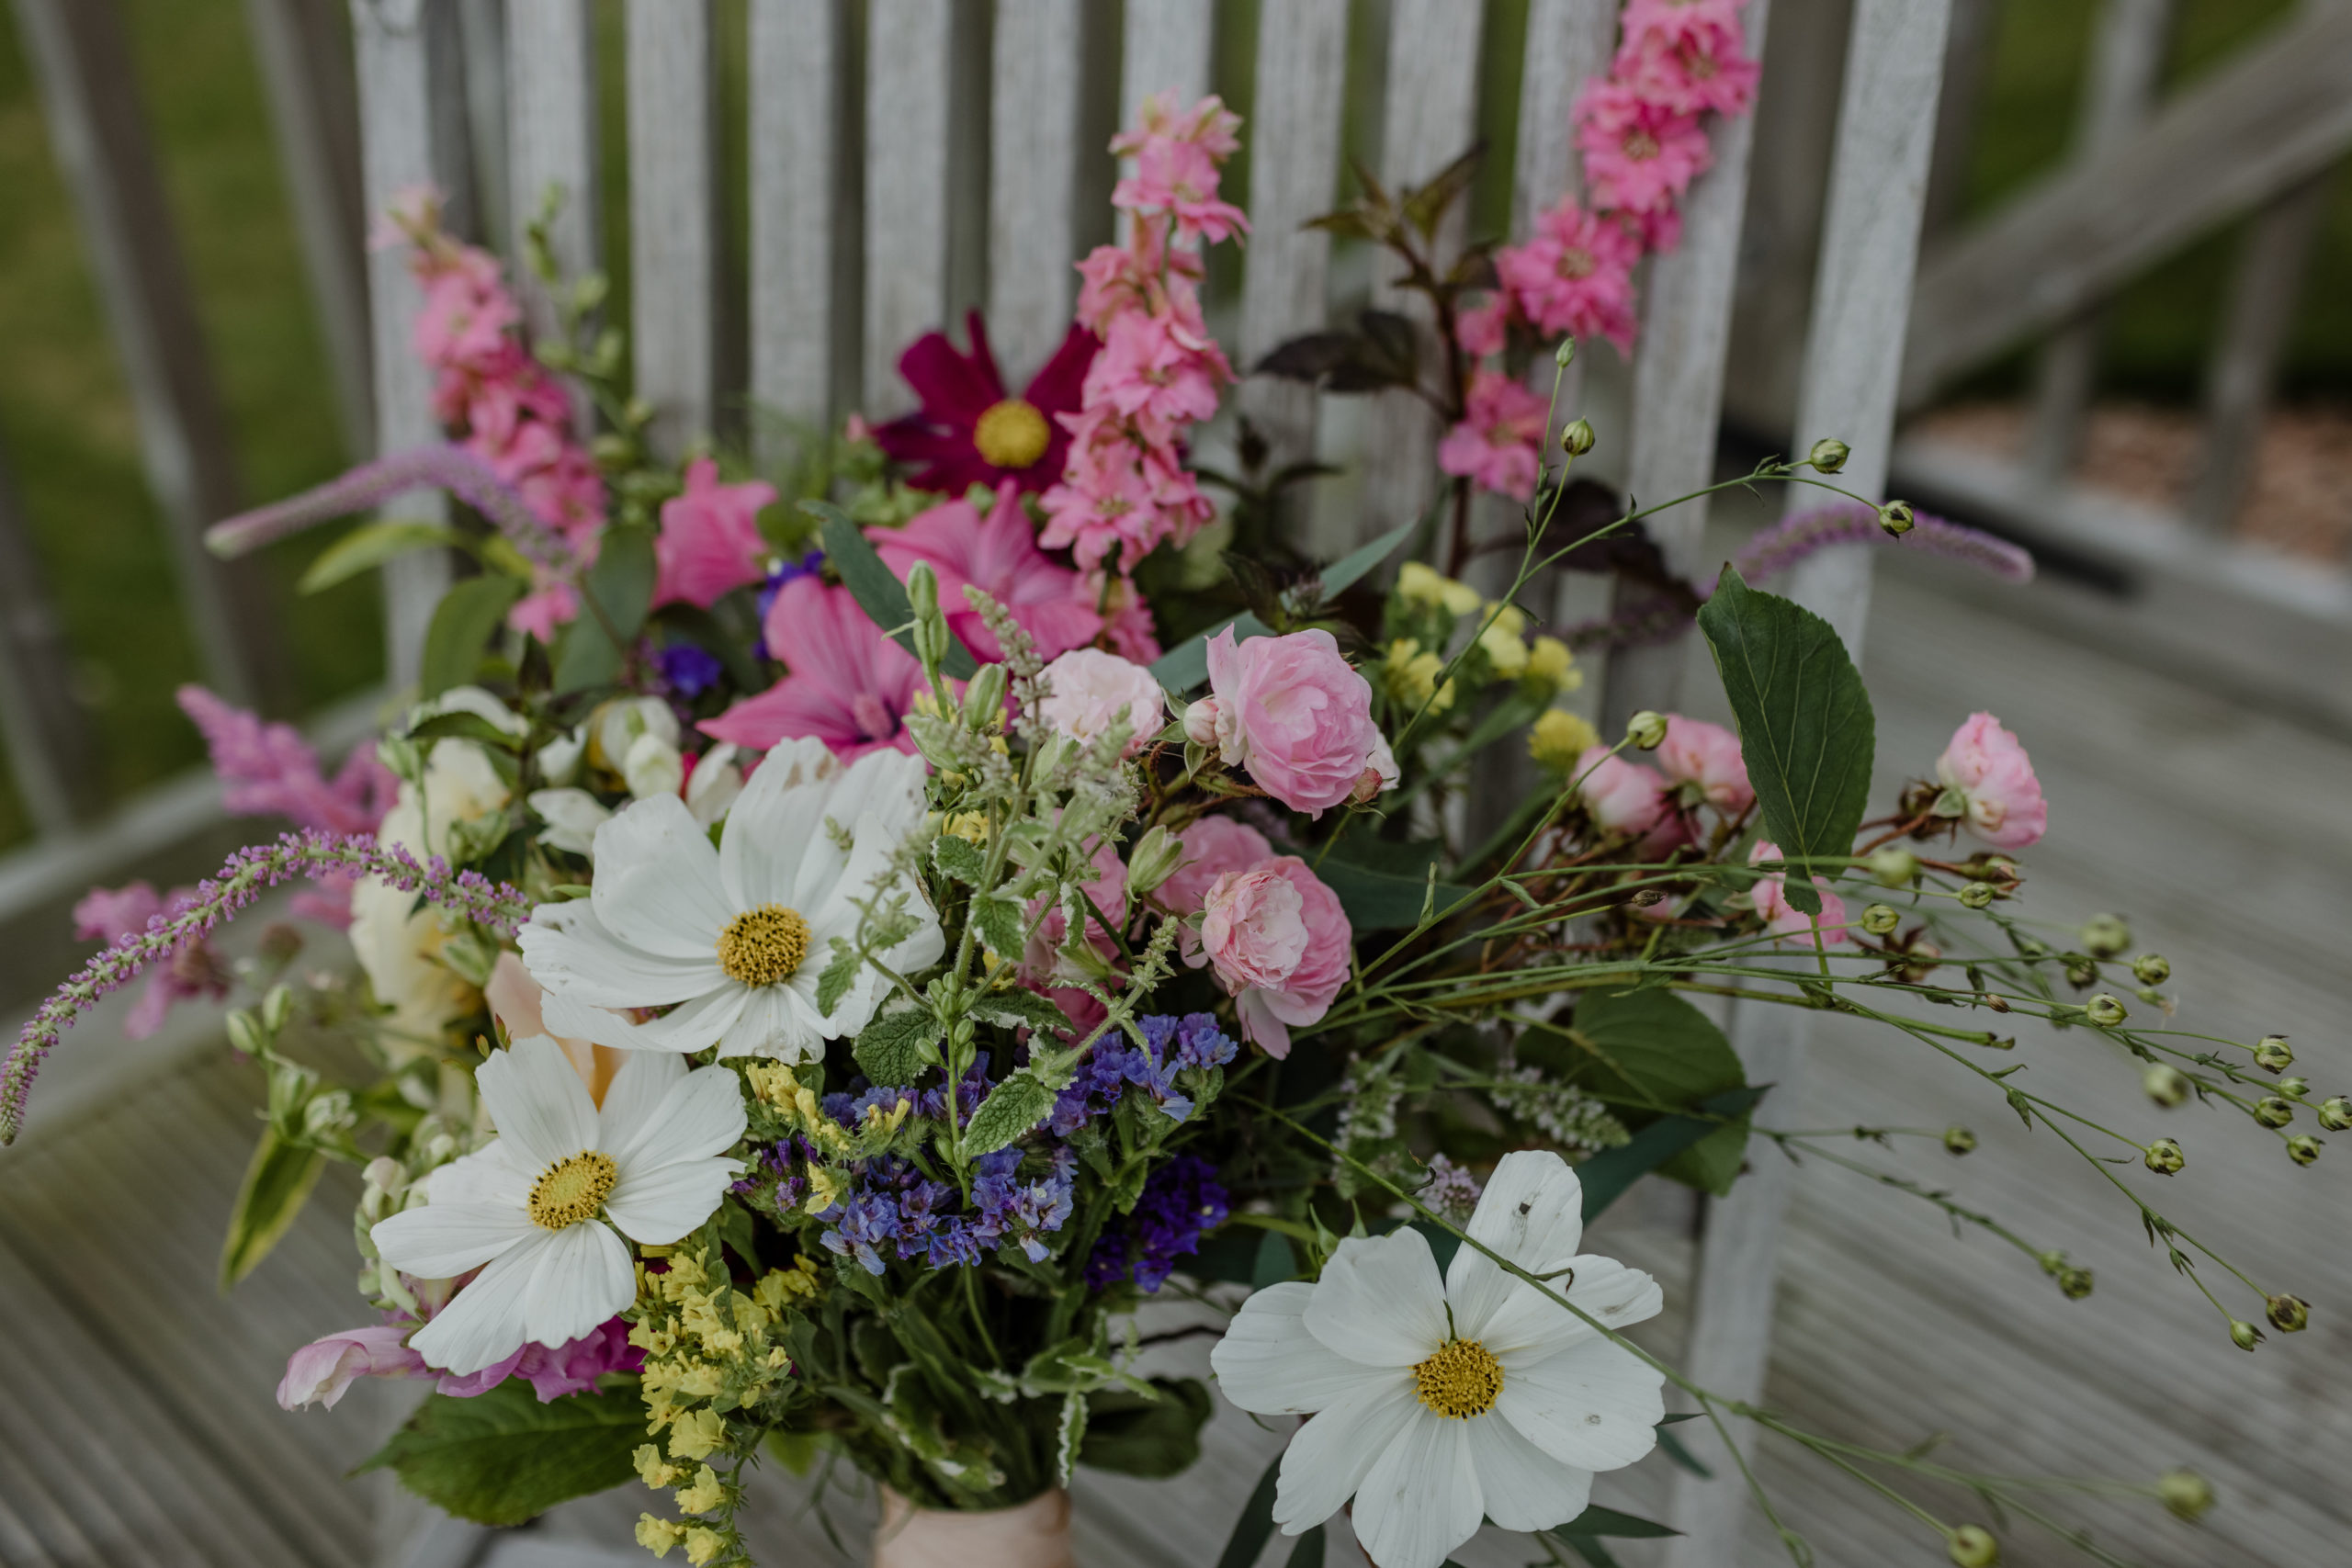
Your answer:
(0, 7), (2314, 1568)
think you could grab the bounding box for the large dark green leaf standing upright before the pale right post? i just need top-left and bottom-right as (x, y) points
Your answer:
(1698, 567), (1877, 915)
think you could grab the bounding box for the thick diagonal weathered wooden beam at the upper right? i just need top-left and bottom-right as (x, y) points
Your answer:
(1903, 5), (2352, 407)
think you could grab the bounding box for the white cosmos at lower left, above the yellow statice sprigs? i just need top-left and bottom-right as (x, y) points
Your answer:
(369, 1034), (743, 1373)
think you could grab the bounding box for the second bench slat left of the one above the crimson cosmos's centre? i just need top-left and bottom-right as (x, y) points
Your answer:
(751, 0), (847, 442)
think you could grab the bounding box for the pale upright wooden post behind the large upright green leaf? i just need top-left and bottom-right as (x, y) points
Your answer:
(1668, 0), (1950, 1568)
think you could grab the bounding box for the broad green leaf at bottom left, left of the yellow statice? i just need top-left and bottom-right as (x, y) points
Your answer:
(360, 1378), (644, 1526)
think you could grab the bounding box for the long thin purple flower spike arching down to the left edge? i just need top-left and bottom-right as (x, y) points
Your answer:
(0, 828), (532, 1145)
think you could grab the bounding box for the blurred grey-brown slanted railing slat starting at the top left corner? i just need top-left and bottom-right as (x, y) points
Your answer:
(14, 0), (291, 707)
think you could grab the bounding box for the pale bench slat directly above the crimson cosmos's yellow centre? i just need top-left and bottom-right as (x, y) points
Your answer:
(988, 0), (1099, 390)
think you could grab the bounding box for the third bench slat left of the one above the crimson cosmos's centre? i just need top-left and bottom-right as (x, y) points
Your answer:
(628, 0), (719, 456)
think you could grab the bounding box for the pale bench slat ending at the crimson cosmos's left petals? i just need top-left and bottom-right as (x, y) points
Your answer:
(861, 0), (953, 419)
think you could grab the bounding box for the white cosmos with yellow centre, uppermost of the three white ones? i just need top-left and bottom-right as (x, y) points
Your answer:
(522, 740), (945, 1063)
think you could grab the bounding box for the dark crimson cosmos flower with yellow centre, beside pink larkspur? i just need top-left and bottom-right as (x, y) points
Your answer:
(875, 310), (1099, 496)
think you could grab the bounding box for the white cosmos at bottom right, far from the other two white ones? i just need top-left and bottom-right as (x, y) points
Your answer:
(1209, 1149), (1665, 1568)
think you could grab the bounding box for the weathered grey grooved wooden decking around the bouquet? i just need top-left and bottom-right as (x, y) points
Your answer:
(0, 569), (2352, 1568)
